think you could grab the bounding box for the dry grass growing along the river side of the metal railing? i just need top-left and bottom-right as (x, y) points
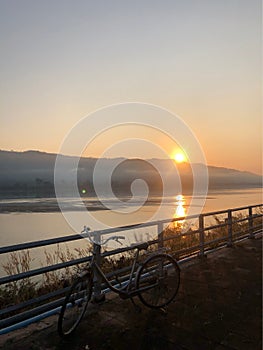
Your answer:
(0, 209), (263, 314)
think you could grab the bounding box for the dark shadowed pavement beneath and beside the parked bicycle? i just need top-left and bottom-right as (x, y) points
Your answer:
(0, 238), (262, 350)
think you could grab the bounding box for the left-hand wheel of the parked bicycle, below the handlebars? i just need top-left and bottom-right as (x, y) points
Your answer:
(58, 275), (92, 337)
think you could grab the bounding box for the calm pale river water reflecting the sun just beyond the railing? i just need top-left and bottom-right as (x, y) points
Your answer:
(0, 189), (262, 270)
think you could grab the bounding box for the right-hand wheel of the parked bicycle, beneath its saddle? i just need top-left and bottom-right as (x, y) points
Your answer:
(136, 254), (180, 309)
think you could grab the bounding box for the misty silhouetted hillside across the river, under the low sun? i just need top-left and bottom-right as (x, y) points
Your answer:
(0, 151), (262, 197)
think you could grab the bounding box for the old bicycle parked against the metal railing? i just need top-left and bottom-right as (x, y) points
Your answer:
(58, 231), (180, 337)
